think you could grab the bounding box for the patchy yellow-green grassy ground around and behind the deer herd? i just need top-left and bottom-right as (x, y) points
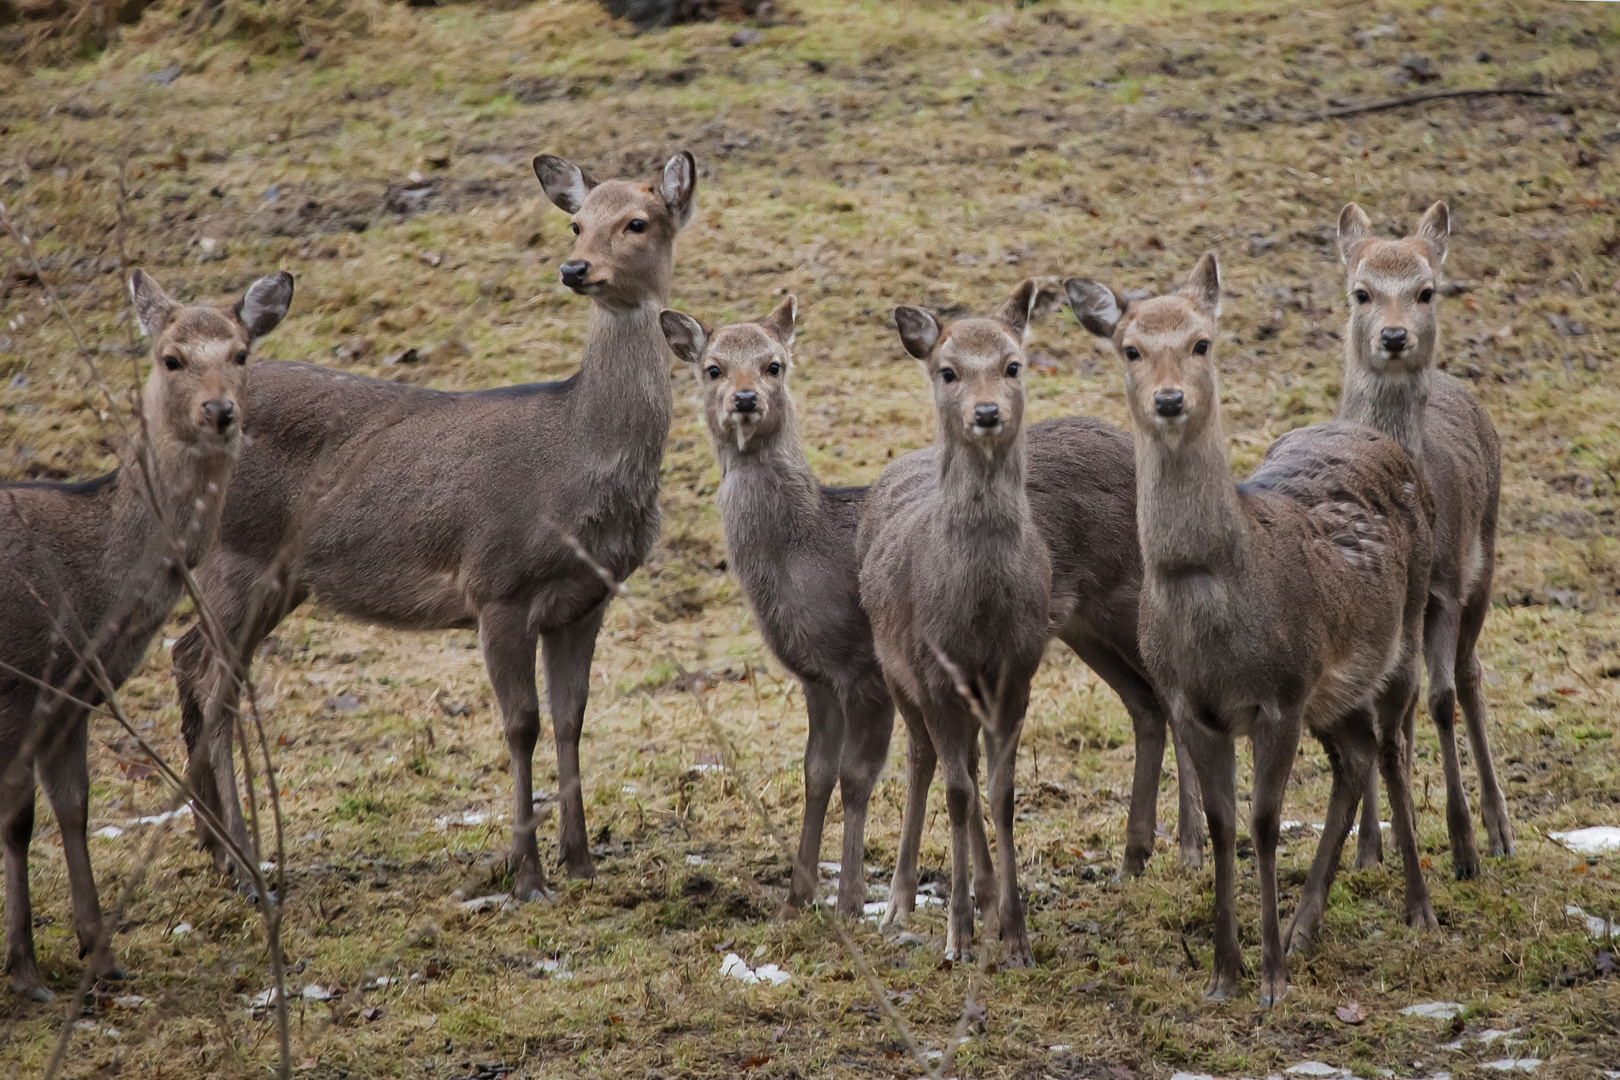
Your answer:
(0, 0), (1620, 1080)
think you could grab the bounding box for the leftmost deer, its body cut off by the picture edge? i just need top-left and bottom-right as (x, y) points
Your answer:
(0, 270), (293, 1001)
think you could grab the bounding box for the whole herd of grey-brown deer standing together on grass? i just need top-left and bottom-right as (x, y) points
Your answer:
(0, 152), (1513, 1006)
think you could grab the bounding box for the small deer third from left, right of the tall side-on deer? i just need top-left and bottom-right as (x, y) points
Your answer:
(661, 296), (894, 916)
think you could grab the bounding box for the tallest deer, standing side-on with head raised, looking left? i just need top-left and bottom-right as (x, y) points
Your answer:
(175, 152), (697, 900)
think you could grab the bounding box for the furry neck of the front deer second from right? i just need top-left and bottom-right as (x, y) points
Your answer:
(1136, 415), (1247, 575)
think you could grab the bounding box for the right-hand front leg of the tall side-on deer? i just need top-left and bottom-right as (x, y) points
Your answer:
(541, 601), (608, 878)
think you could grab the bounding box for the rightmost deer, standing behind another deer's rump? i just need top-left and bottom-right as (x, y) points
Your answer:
(1338, 202), (1513, 878)
